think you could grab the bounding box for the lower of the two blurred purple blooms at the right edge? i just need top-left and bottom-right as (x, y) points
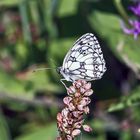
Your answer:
(121, 20), (140, 39)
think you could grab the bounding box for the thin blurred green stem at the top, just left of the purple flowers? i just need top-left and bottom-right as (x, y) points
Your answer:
(114, 0), (130, 26)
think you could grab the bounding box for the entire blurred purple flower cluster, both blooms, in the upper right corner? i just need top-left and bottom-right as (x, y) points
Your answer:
(122, 2), (140, 39)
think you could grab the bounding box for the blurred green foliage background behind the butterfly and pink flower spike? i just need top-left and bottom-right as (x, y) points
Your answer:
(0, 0), (140, 140)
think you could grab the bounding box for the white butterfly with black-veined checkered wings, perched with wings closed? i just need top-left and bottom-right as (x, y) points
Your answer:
(57, 33), (107, 86)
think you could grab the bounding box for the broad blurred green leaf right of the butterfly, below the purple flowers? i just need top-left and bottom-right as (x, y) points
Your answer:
(89, 11), (140, 64)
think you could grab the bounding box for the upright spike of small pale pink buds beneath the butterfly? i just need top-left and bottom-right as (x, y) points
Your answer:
(57, 80), (93, 140)
